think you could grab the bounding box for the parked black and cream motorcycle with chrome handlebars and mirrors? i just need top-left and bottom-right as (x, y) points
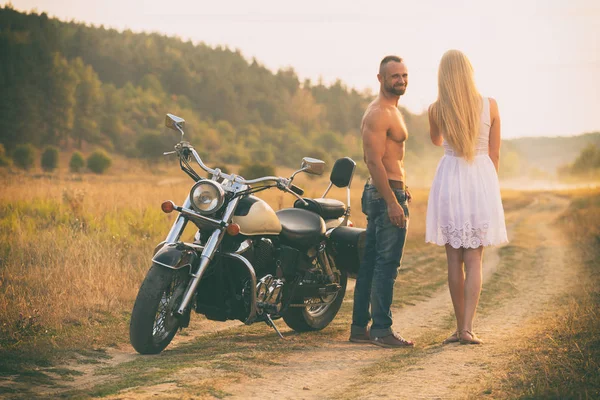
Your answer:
(130, 114), (365, 354)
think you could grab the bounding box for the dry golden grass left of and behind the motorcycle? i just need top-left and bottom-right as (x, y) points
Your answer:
(0, 160), (436, 369)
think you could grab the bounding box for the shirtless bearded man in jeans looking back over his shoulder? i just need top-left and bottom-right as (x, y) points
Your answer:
(350, 56), (414, 347)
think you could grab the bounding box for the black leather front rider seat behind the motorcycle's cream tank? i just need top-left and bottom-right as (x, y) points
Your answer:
(276, 208), (325, 250)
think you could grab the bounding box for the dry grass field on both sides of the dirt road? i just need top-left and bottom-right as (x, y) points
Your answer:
(0, 161), (600, 398)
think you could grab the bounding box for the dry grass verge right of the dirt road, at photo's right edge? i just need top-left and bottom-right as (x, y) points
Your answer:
(472, 189), (600, 399)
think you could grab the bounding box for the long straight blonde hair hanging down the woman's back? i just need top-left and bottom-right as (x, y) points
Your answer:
(432, 50), (481, 160)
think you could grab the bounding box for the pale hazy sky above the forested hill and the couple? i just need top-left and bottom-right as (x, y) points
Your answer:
(0, 0), (600, 138)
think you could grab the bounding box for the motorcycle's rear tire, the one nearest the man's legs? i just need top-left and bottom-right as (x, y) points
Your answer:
(282, 271), (348, 332)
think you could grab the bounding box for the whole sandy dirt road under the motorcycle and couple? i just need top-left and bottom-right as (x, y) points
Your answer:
(27, 193), (578, 399)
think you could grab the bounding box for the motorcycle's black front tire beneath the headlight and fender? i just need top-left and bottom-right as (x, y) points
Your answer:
(129, 264), (190, 354)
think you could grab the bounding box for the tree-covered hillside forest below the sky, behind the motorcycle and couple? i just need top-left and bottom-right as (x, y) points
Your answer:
(0, 4), (600, 181)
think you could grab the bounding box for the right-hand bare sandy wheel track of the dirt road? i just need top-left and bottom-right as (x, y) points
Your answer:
(337, 192), (577, 399)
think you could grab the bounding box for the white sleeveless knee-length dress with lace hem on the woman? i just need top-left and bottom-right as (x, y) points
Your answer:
(425, 97), (508, 249)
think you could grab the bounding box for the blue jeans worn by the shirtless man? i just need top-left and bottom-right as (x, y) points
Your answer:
(351, 184), (409, 338)
